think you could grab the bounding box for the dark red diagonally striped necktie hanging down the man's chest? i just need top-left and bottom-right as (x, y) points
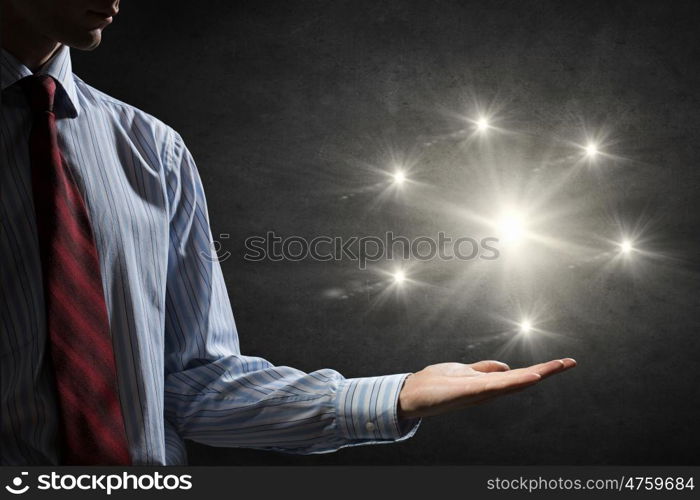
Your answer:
(20, 75), (131, 465)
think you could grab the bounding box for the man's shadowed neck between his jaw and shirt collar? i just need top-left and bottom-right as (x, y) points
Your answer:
(2, 2), (61, 72)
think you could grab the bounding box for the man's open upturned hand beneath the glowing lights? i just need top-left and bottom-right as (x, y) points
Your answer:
(398, 358), (576, 418)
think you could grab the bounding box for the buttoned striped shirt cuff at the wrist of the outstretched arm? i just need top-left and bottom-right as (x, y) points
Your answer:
(336, 373), (420, 442)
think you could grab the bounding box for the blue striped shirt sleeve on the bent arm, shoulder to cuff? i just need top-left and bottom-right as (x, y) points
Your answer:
(164, 132), (420, 454)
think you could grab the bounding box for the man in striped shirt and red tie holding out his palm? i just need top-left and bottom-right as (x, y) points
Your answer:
(0, 0), (575, 465)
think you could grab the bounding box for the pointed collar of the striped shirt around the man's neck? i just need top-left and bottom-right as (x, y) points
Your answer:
(0, 45), (80, 118)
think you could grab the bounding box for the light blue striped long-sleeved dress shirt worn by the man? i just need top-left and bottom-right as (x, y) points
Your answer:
(0, 47), (419, 465)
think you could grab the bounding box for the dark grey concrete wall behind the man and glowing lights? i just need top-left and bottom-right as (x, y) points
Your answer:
(74, 0), (700, 464)
